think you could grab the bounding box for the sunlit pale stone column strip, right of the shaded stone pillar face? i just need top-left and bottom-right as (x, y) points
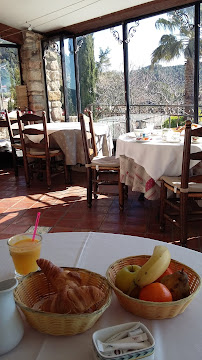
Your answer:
(44, 39), (65, 122)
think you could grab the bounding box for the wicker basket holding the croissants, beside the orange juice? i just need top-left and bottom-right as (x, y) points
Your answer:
(14, 267), (111, 335)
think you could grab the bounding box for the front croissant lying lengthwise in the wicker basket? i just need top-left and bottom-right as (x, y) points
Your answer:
(41, 285), (104, 314)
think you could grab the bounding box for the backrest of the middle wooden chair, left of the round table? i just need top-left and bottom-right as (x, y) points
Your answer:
(79, 111), (97, 164)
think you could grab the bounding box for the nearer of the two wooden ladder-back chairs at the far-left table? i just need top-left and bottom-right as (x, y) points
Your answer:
(17, 111), (67, 190)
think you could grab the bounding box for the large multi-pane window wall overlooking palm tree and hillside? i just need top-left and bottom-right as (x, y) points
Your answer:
(42, 5), (202, 132)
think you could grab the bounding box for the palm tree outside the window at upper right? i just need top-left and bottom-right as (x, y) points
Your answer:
(151, 7), (194, 115)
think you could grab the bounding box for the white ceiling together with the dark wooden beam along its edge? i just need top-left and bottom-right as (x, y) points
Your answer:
(0, 0), (195, 45)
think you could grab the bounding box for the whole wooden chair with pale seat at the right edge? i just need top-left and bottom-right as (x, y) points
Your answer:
(160, 120), (202, 246)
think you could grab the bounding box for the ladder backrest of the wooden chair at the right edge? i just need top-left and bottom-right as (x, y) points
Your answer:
(181, 120), (202, 189)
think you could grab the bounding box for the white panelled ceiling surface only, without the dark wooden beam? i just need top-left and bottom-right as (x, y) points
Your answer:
(0, 0), (152, 33)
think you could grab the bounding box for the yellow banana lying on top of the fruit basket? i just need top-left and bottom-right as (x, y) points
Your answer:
(135, 245), (171, 287)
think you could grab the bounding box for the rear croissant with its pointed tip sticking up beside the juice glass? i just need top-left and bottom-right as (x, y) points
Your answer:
(36, 259), (81, 292)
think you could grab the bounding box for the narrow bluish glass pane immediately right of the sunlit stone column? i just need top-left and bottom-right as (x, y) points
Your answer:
(64, 39), (78, 121)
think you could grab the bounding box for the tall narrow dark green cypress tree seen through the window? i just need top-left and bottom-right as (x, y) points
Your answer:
(78, 34), (96, 112)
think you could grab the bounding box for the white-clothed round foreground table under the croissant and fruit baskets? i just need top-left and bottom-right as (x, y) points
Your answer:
(0, 232), (202, 360)
